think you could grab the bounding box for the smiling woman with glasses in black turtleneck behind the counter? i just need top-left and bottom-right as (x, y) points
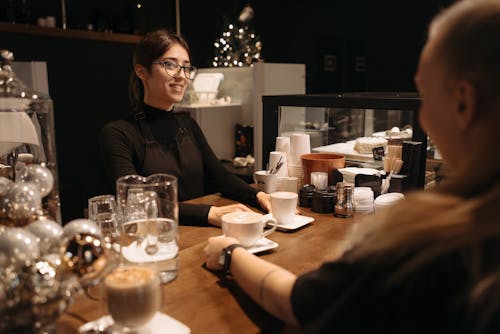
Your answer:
(101, 29), (270, 226)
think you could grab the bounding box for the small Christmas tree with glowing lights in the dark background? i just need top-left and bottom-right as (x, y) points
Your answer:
(212, 5), (262, 67)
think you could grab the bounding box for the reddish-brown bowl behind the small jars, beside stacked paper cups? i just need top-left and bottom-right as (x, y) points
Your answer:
(300, 153), (345, 185)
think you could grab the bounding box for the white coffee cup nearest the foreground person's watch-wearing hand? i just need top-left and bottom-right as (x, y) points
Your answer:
(222, 211), (277, 247)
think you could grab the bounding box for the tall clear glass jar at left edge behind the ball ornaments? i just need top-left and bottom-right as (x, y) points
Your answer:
(0, 50), (61, 223)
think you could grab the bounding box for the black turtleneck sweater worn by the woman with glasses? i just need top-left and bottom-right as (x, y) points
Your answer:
(100, 105), (258, 225)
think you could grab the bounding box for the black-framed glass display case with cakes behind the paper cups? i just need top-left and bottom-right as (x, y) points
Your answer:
(262, 92), (441, 188)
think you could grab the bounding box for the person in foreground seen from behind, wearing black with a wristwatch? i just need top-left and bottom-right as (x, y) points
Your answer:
(205, 0), (500, 333)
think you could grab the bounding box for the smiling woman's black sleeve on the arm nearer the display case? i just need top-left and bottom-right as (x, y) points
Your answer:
(185, 117), (260, 209)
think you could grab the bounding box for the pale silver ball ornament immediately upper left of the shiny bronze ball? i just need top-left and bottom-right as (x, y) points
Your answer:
(25, 218), (63, 255)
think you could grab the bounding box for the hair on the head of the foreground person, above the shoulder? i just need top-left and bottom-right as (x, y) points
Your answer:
(429, 0), (500, 111)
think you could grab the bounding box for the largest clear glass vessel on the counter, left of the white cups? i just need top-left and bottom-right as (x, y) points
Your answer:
(116, 174), (179, 283)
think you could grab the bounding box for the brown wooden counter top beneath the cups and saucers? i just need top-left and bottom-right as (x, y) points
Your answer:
(57, 195), (356, 334)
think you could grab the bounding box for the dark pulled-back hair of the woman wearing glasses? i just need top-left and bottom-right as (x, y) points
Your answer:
(128, 29), (191, 110)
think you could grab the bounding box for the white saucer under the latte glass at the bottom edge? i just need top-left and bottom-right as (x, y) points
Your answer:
(78, 312), (191, 334)
